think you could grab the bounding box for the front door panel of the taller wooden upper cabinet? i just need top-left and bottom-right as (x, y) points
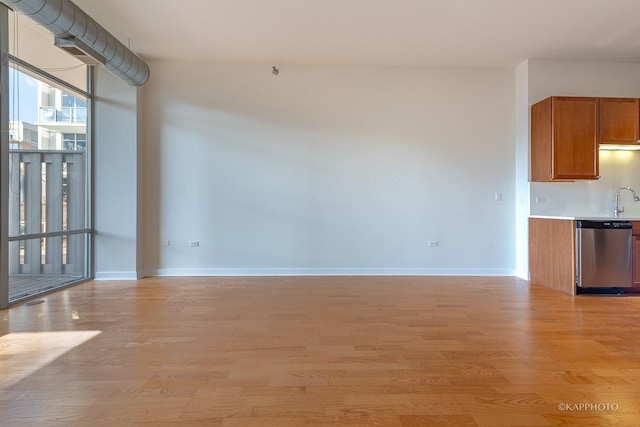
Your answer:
(552, 97), (599, 180)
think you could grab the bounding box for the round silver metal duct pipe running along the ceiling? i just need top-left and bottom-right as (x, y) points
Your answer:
(0, 0), (149, 86)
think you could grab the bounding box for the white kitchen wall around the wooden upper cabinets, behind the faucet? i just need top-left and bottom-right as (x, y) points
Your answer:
(528, 60), (640, 216)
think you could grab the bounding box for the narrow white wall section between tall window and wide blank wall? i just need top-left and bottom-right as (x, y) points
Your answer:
(94, 68), (140, 279)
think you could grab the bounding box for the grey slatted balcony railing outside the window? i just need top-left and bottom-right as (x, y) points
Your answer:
(9, 150), (90, 280)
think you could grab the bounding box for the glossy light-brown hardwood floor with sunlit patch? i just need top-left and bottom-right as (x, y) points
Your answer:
(0, 277), (640, 427)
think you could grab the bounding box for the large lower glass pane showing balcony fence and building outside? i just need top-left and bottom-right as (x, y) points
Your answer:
(4, 60), (90, 302)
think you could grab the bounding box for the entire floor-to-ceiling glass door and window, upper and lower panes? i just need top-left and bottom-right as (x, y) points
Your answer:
(0, 7), (92, 305)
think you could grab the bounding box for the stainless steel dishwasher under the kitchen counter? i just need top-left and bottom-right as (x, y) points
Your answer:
(576, 221), (632, 288)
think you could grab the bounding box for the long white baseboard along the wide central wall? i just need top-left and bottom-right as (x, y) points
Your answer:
(144, 268), (516, 277)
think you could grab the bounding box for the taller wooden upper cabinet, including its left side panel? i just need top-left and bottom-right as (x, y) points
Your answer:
(531, 96), (599, 181)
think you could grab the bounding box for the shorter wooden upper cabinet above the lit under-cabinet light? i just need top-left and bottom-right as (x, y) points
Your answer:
(598, 98), (640, 144)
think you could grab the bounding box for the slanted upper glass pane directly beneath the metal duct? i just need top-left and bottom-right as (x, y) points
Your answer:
(9, 11), (87, 91)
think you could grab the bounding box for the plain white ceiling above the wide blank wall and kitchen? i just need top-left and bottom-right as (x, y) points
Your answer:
(73, 0), (640, 66)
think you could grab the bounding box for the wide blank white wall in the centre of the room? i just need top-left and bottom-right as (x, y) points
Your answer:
(143, 61), (515, 275)
